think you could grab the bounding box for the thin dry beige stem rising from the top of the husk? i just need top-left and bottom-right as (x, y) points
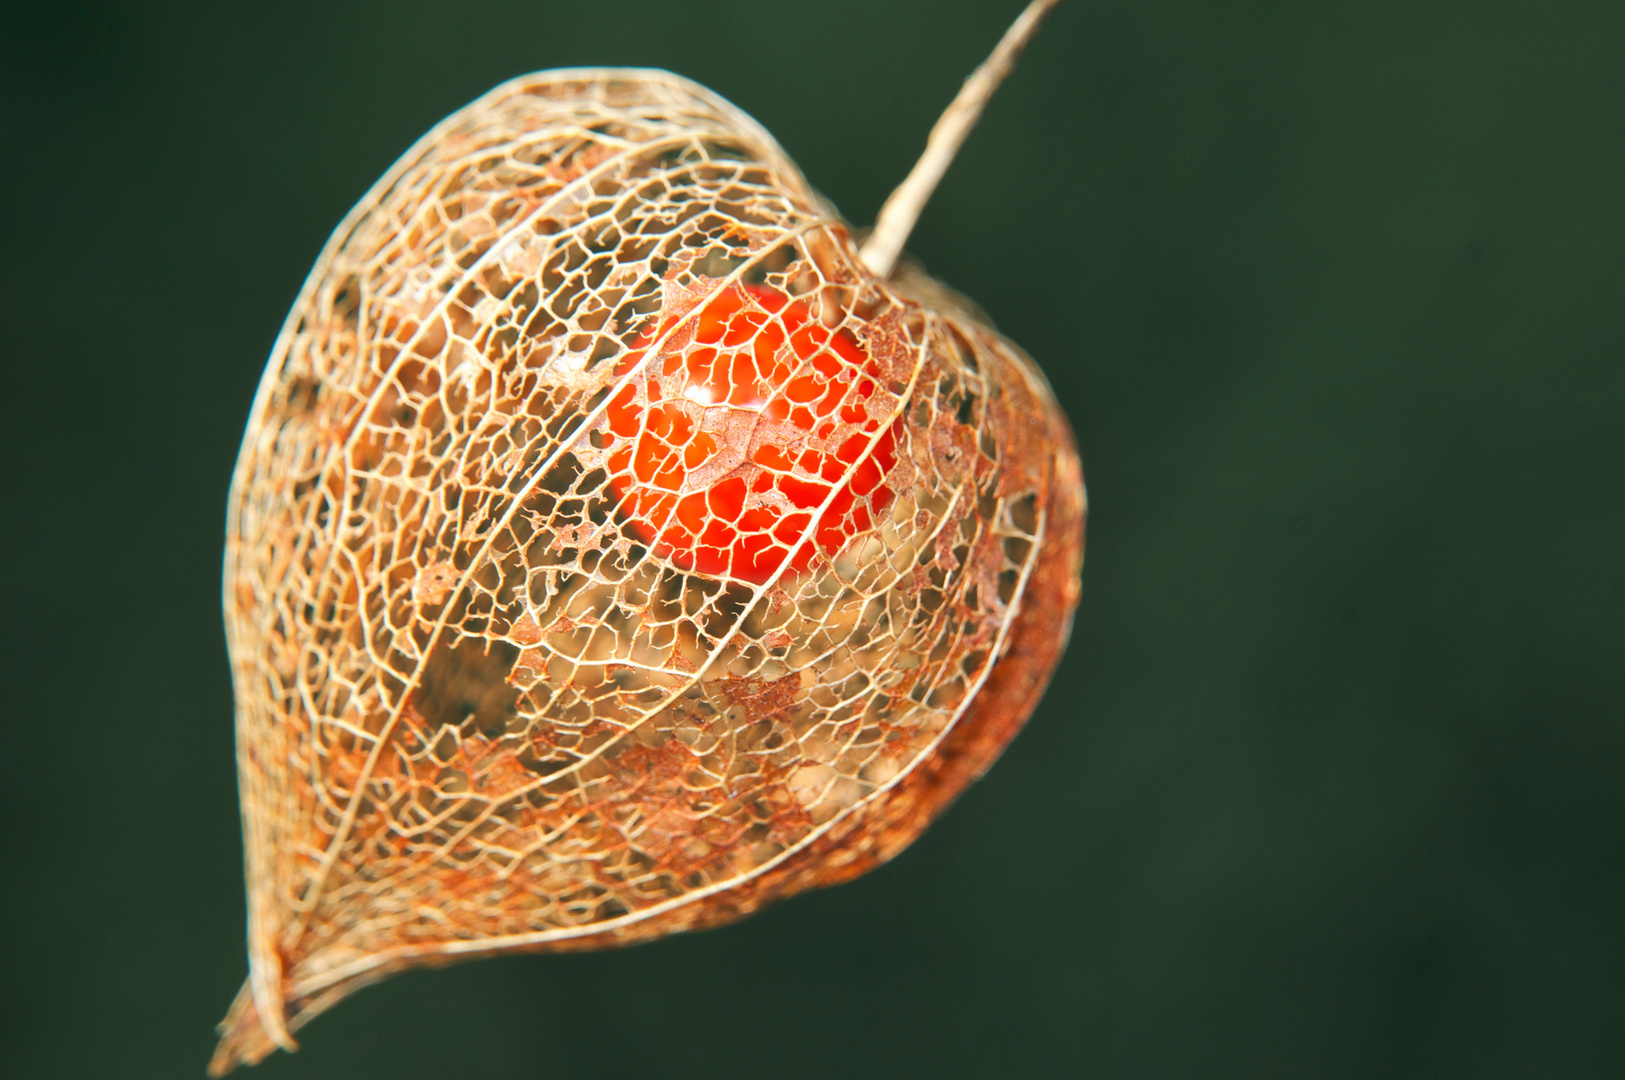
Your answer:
(858, 0), (1061, 278)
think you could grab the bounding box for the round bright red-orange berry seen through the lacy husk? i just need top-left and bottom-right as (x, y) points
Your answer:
(606, 284), (902, 585)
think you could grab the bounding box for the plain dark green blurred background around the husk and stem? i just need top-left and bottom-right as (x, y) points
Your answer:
(0, 0), (1625, 1080)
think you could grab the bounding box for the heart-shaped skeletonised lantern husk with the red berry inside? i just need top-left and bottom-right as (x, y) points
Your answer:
(211, 6), (1084, 1074)
